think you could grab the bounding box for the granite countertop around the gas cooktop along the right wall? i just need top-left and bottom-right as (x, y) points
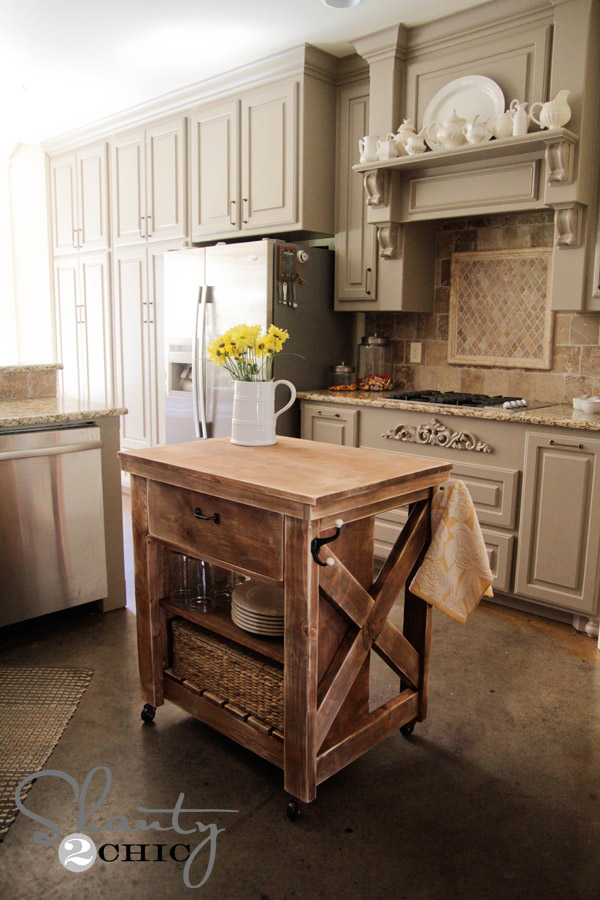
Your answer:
(297, 390), (600, 431)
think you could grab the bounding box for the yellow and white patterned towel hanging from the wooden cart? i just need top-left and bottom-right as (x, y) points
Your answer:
(410, 480), (493, 622)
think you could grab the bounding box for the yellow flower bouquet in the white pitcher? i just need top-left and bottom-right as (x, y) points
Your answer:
(207, 324), (289, 381)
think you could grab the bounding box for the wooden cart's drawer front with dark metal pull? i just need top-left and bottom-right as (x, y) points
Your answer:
(148, 480), (283, 581)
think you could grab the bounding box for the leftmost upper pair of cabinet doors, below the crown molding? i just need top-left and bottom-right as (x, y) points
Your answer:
(50, 143), (108, 255)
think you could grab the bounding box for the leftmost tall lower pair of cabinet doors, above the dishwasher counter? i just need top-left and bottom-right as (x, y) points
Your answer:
(54, 252), (114, 408)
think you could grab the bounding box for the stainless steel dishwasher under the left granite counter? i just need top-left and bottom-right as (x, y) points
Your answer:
(0, 425), (107, 625)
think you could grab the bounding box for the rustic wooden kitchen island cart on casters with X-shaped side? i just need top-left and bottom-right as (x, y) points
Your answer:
(120, 438), (451, 818)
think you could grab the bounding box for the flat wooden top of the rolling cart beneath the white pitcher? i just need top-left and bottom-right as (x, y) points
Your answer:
(119, 437), (451, 519)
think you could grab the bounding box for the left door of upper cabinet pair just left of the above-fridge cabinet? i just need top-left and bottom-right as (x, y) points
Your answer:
(111, 131), (147, 246)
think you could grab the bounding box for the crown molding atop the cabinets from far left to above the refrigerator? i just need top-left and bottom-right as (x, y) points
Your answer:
(42, 44), (339, 156)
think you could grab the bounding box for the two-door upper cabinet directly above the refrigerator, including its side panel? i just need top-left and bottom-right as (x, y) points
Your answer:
(191, 76), (335, 241)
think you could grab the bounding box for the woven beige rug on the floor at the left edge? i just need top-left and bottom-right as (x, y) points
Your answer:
(0, 666), (93, 841)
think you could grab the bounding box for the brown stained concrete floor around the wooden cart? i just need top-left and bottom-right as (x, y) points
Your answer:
(0, 500), (600, 900)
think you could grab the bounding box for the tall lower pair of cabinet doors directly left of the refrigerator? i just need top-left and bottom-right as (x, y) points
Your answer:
(113, 241), (182, 449)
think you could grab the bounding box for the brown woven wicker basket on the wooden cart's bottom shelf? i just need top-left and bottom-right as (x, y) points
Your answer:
(171, 618), (283, 731)
